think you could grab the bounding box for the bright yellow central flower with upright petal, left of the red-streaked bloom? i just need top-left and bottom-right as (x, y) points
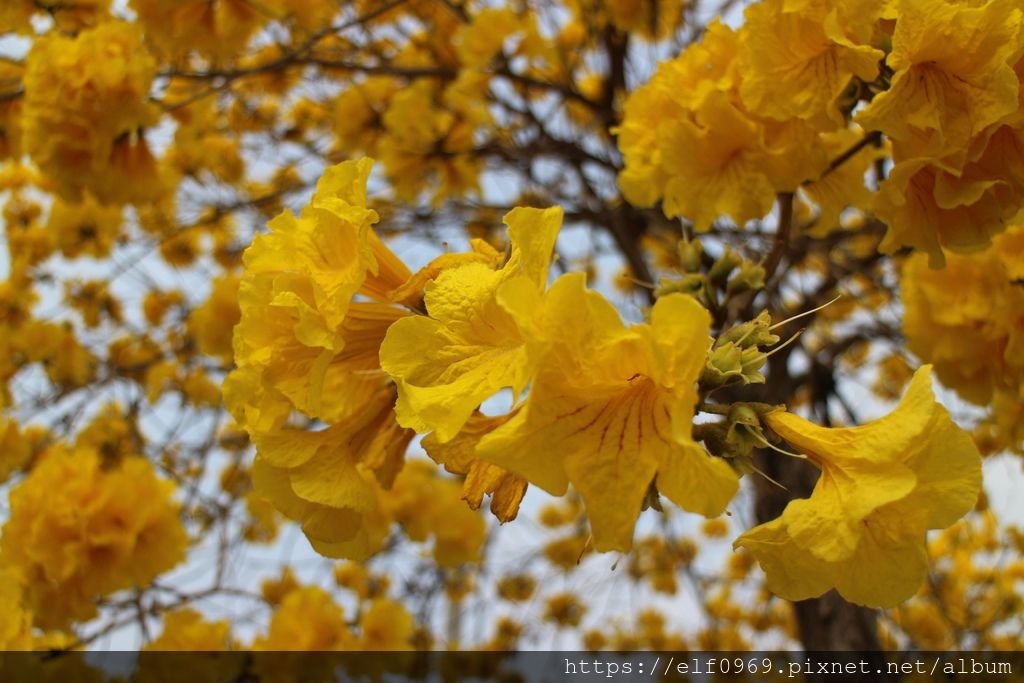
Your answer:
(380, 202), (562, 442)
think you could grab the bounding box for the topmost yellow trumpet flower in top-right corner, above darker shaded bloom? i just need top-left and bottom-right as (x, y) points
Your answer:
(857, 0), (1024, 167)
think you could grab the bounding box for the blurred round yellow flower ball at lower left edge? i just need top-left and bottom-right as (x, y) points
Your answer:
(0, 446), (187, 628)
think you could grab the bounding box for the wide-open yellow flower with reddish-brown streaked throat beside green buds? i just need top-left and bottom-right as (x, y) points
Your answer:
(476, 273), (738, 551)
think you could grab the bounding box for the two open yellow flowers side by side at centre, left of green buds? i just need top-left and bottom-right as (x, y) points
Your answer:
(381, 209), (737, 551)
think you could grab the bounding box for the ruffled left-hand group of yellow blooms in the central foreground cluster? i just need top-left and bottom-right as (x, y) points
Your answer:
(224, 160), (419, 557)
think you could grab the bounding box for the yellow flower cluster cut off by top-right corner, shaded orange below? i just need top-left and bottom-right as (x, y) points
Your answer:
(858, 0), (1024, 265)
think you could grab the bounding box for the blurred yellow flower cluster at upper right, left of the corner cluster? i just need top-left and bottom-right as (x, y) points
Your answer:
(617, 0), (883, 230)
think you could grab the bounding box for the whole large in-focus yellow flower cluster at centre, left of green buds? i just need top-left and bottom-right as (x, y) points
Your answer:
(225, 161), (738, 560)
